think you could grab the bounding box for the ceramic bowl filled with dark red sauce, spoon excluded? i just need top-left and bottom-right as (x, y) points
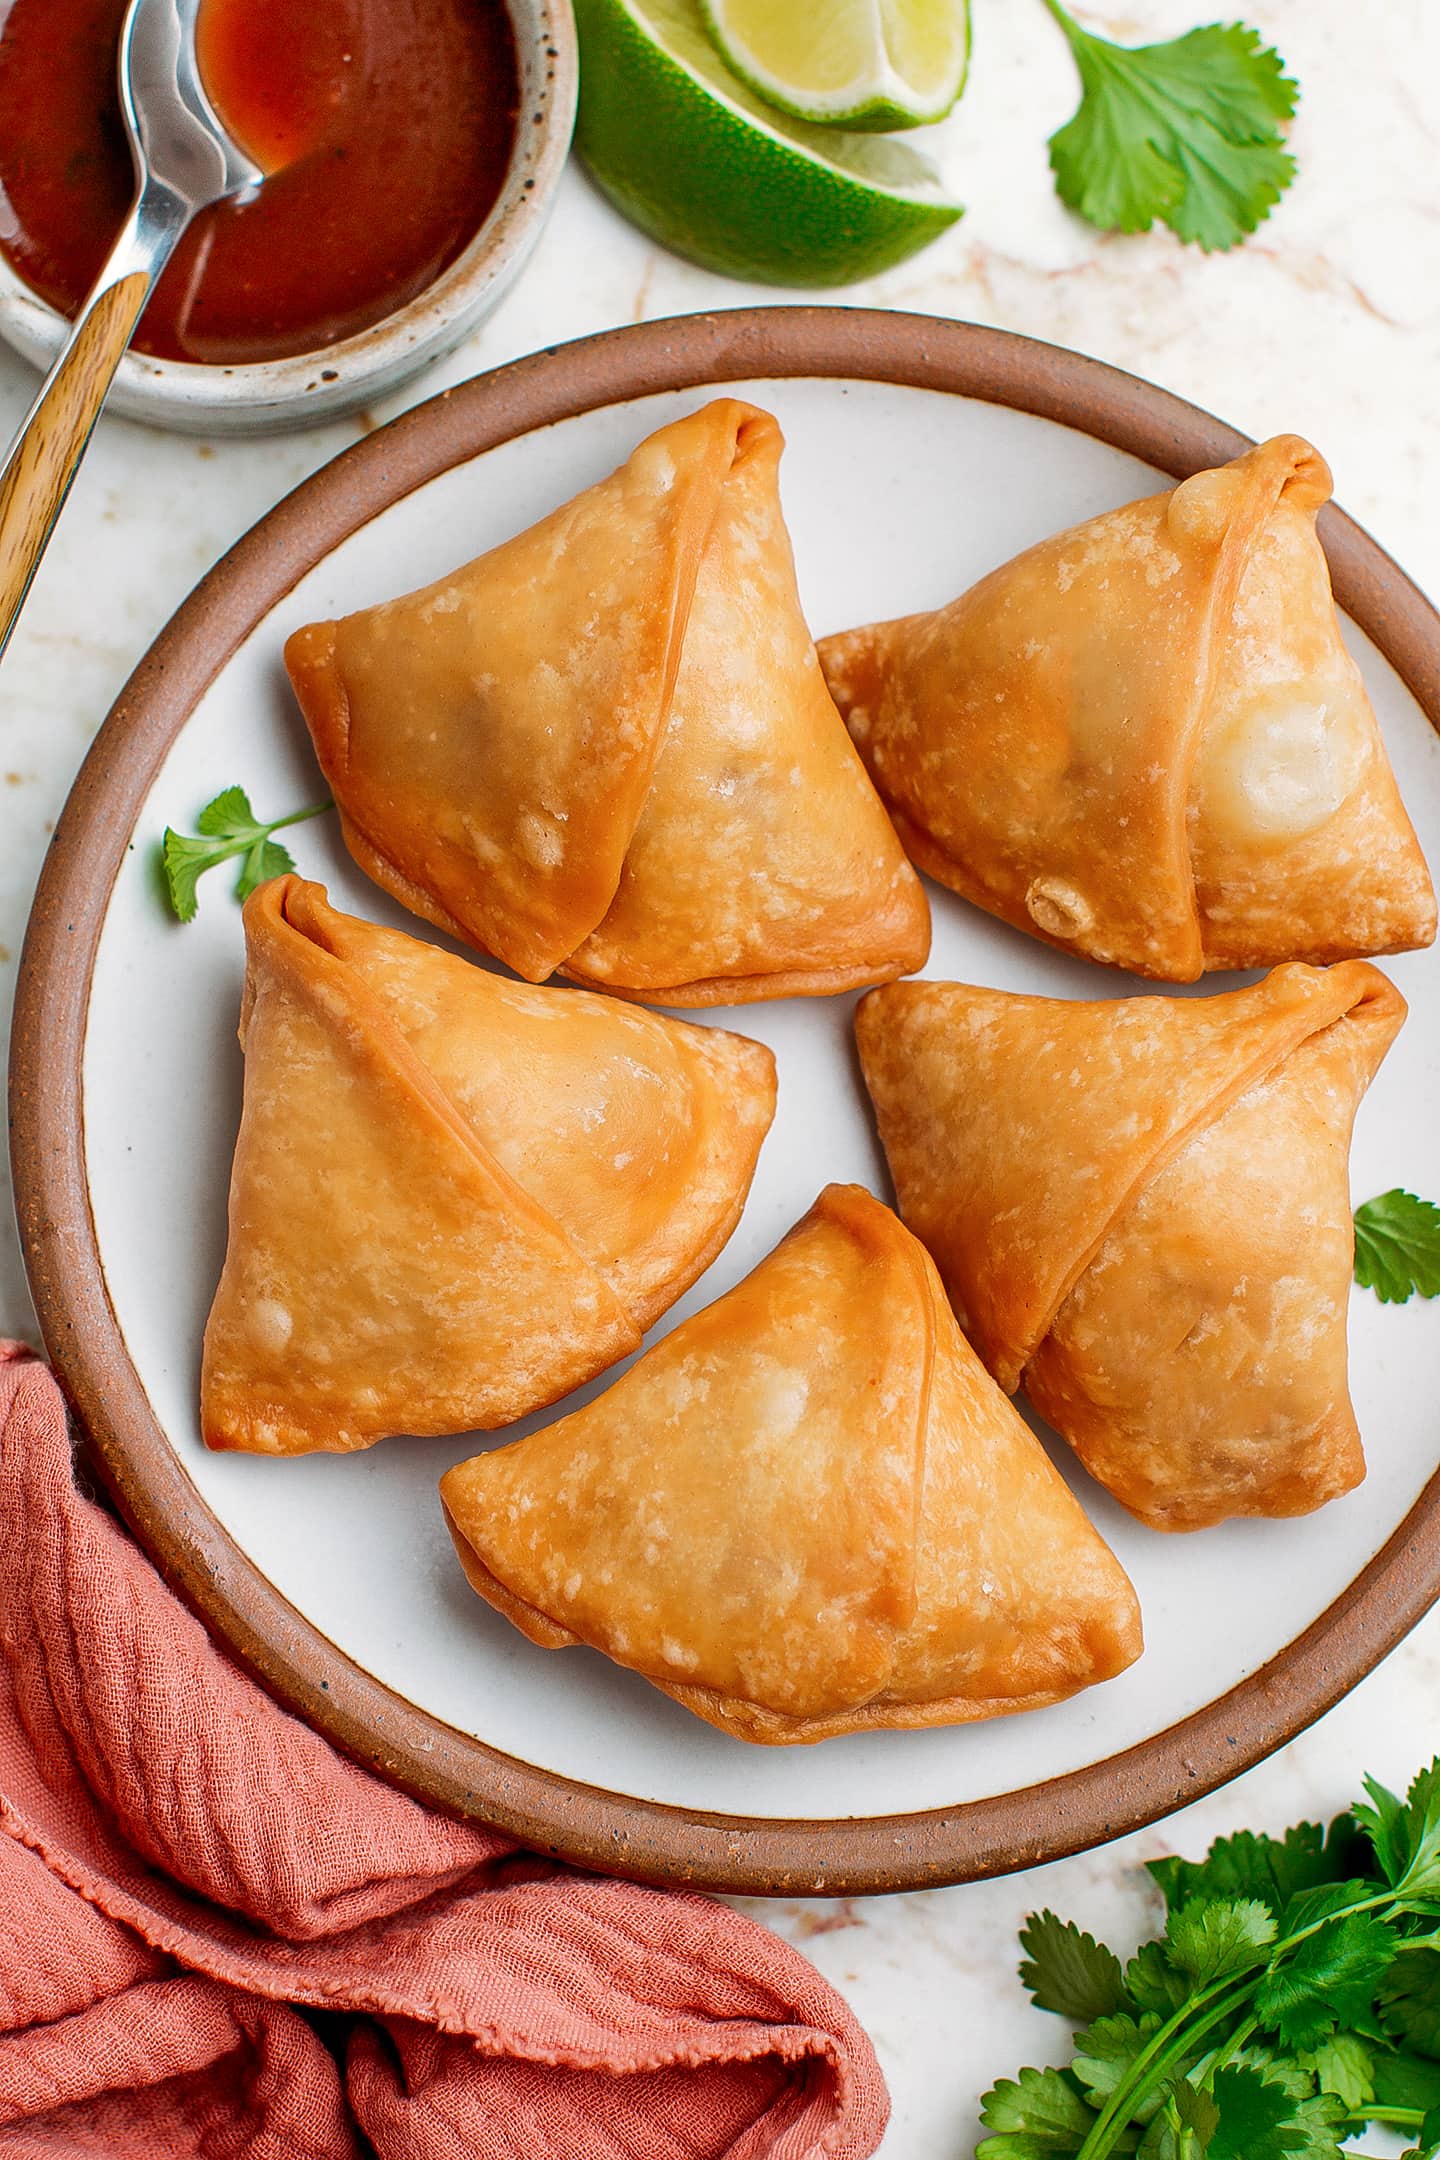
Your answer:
(0, 0), (574, 432)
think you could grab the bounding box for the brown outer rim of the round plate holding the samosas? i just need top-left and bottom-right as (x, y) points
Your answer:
(11, 307), (1440, 1896)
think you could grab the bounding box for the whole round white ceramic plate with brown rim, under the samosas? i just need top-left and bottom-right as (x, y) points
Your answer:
(13, 309), (1440, 1892)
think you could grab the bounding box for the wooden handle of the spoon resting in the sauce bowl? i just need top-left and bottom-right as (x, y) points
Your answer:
(0, 270), (151, 652)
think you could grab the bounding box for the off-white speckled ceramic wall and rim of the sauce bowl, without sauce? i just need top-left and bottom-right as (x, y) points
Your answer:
(0, 0), (579, 434)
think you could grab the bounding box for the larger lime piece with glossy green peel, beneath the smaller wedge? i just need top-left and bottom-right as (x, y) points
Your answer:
(574, 0), (961, 285)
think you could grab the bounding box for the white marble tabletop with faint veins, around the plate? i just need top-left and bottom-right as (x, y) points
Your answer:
(0, 0), (1440, 2160)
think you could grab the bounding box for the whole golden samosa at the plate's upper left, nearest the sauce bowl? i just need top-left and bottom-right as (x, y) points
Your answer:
(285, 397), (930, 1004)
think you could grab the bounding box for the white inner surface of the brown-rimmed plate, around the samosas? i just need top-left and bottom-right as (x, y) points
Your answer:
(19, 319), (1440, 1879)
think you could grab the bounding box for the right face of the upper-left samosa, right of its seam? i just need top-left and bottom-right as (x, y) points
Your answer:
(568, 408), (928, 991)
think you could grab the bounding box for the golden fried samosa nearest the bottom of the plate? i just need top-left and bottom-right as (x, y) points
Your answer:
(440, 1186), (1140, 1743)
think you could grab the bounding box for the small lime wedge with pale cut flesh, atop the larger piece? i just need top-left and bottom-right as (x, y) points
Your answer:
(699, 0), (969, 127)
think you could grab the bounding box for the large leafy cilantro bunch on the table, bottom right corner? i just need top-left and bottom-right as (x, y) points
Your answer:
(976, 1758), (1440, 2160)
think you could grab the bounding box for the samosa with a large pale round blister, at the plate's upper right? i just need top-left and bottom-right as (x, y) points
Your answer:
(820, 434), (1436, 983)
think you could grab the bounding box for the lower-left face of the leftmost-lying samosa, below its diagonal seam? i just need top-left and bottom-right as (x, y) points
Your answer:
(201, 886), (639, 1454)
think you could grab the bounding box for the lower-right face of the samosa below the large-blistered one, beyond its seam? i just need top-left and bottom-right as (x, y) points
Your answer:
(1025, 1017), (1369, 1529)
